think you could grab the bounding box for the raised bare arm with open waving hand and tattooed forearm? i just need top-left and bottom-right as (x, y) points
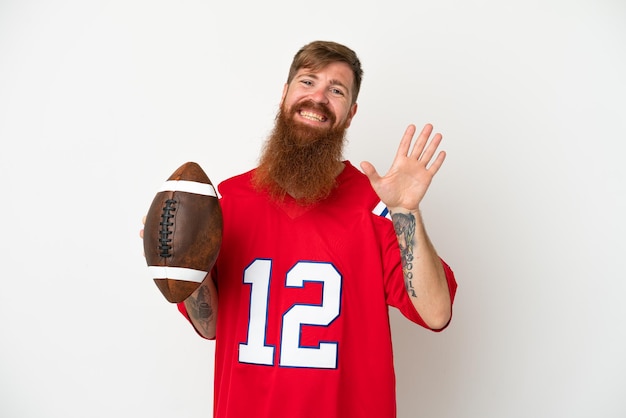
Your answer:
(361, 125), (452, 329)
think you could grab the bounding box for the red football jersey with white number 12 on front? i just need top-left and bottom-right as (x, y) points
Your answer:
(180, 162), (456, 418)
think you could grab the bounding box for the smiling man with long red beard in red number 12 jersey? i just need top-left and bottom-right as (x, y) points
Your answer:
(152, 41), (456, 418)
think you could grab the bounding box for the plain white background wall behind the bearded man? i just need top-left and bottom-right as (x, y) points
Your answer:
(0, 0), (626, 418)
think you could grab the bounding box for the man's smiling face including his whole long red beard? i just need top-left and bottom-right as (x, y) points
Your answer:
(255, 63), (357, 204)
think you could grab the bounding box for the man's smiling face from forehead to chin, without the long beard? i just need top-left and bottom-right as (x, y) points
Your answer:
(281, 62), (357, 132)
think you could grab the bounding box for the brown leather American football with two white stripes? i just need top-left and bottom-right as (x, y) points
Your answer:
(143, 162), (222, 303)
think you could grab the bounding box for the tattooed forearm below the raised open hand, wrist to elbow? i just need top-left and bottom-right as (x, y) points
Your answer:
(391, 209), (451, 329)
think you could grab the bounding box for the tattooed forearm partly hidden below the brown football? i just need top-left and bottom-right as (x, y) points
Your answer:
(185, 274), (217, 339)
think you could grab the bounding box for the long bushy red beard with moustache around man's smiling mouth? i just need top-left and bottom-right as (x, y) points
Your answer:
(254, 102), (346, 205)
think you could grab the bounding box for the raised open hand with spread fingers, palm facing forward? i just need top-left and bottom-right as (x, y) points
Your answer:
(361, 124), (446, 211)
